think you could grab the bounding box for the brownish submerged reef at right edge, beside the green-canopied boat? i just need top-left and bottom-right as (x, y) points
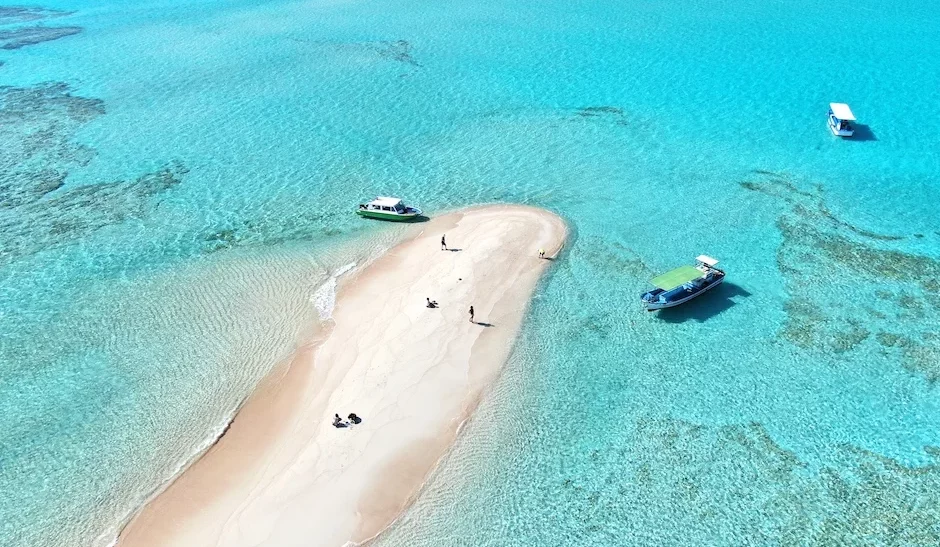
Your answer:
(741, 171), (940, 382)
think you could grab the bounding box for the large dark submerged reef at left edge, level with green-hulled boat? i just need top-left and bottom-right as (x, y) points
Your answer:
(0, 83), (186, 265)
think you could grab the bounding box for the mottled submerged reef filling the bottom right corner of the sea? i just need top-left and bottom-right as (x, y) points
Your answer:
(548, 417), (940, 547)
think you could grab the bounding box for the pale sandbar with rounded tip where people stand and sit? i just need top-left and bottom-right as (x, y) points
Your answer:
(118, 206), (566, 547)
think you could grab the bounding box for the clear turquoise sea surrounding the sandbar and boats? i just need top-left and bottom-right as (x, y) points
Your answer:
(0, 0), (940, 547)
